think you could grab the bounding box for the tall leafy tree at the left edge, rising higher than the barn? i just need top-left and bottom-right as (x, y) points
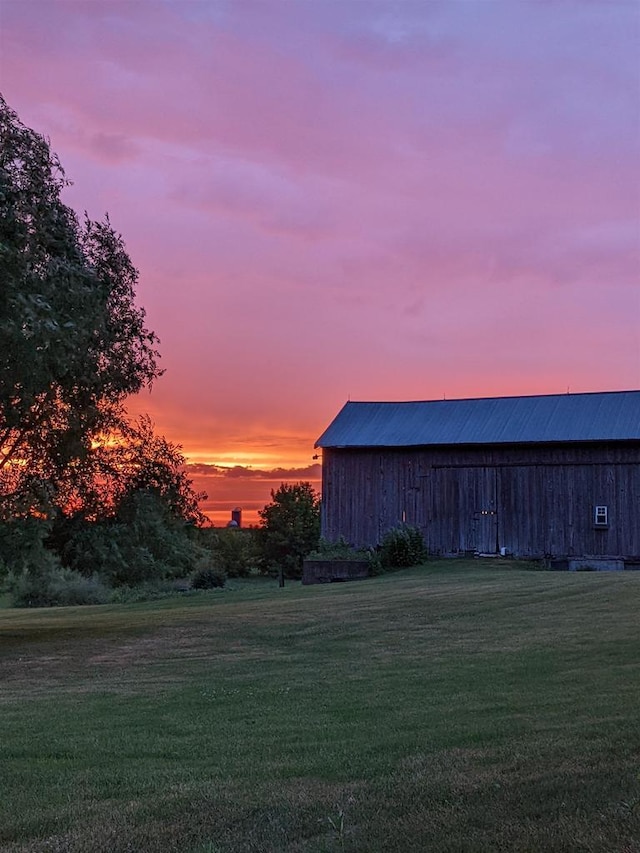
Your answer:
(0, 96), (161, 514)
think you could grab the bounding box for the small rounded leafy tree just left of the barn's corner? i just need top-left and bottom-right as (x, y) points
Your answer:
(258, 482), (320, 578)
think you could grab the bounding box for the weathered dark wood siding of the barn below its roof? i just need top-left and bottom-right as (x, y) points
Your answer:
(322, 442), (640, 557)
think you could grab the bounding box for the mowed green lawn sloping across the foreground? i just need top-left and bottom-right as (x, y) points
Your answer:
(0, 561), (640, 853)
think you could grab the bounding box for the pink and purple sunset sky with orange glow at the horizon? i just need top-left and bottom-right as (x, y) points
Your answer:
(0, 0), (640, 524)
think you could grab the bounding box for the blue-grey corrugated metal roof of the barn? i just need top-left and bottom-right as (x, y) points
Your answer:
(316, 391), (640, 447)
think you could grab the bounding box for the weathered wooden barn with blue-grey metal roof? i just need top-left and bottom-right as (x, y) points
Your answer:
(316, 391), (640, 565)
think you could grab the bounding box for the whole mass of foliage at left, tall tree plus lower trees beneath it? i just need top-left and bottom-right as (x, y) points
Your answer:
(0, 96), (204, 586)
